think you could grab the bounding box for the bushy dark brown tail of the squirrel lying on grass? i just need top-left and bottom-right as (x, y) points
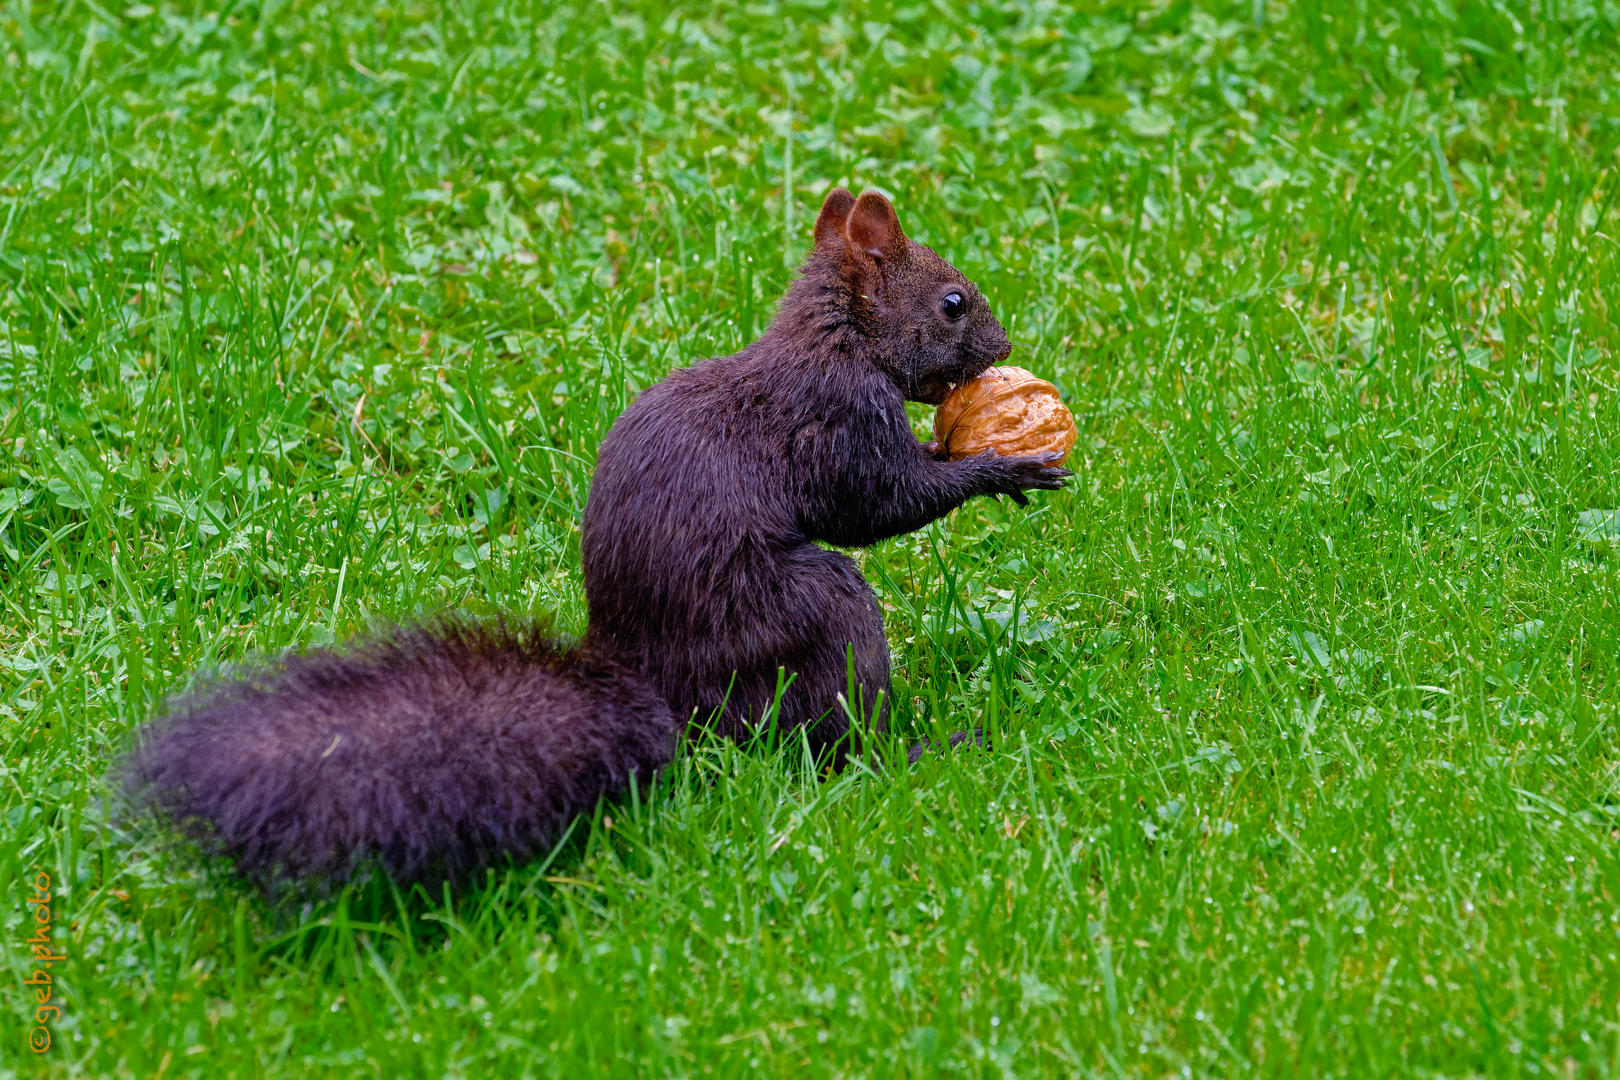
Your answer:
(123, 620), (679, 884)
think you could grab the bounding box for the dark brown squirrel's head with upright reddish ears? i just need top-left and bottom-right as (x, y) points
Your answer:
(807, 188), (1013, 405)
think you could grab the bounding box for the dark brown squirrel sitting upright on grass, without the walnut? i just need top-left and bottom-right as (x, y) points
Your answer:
(123, 188), (1069, 886)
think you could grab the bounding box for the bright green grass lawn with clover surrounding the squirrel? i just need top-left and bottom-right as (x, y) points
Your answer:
(0, 0), (1620, 1078)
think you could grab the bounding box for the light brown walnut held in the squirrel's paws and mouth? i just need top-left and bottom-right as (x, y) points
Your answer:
(933, 368), (1081, 465)
